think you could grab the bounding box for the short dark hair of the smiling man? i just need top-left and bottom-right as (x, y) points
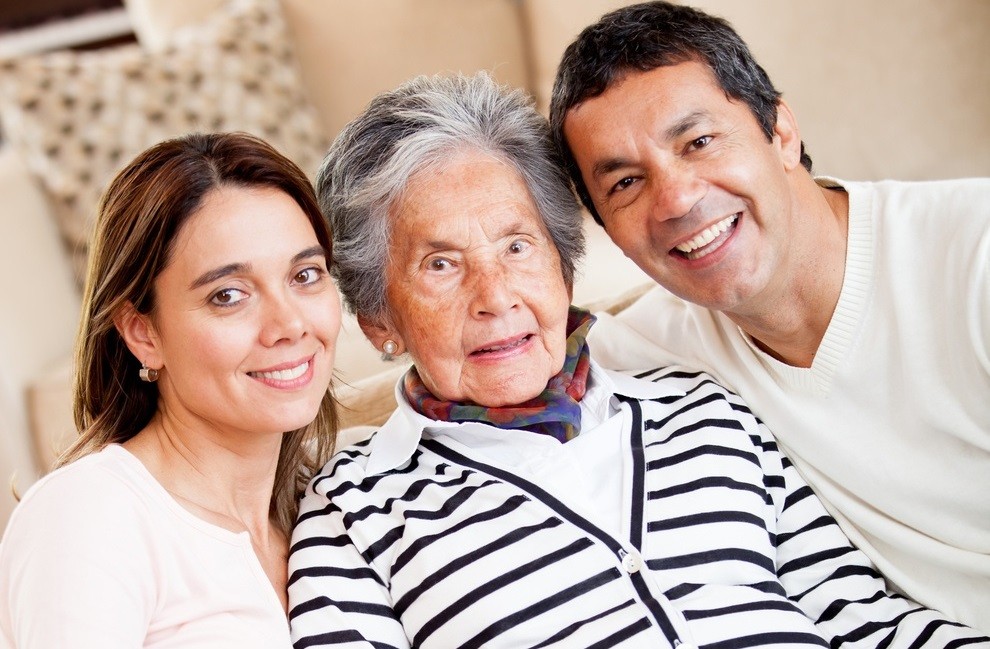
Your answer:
(550, 2), (811, 223)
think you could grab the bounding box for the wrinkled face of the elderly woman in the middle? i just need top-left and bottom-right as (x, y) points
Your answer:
(369, 151), (570, 406)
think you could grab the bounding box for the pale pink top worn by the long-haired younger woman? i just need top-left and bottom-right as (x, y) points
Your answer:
(0, 445), (291, 649)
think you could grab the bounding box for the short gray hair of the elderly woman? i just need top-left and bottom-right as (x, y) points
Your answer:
(316, 72), (584, 318)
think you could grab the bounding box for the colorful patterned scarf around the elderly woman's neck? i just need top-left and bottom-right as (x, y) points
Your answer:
(404, 306), (595, 442)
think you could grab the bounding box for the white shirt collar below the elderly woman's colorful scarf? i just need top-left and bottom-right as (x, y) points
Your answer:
(366, 361), (684, 475)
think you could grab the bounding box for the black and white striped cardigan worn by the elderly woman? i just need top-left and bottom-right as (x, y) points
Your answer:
(289, 368), (990, 649)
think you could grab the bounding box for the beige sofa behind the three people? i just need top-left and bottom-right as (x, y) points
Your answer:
(0, 0), (990, 529)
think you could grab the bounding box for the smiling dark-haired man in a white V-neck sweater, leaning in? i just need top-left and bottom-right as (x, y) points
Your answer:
(550, 2), (990, 631)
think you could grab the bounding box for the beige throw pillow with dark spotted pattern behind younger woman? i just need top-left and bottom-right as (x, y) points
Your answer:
(0, 0), (329, 280)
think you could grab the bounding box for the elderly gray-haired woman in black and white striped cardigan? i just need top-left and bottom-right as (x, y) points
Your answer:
(289, 75), (990, 648)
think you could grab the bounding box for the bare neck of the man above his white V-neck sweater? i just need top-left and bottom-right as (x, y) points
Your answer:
(726, 176), (849, 367)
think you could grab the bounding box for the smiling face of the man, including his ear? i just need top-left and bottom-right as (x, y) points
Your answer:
(564, 61), (800, 314)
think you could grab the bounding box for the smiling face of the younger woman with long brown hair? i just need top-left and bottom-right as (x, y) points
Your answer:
(141, 187), (340, 434)
